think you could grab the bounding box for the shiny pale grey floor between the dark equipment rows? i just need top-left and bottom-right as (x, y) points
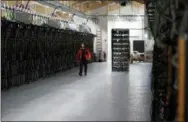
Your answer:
(1, 63), (151, 121)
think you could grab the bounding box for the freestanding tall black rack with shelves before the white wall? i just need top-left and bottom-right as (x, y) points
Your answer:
(112, 29), (130, 71)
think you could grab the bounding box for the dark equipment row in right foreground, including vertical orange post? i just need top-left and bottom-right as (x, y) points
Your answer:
(146, 0), (188, 122)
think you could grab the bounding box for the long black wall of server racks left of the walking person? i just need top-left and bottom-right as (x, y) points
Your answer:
(1, 18), (94, 90)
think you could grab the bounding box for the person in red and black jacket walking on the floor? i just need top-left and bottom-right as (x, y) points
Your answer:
(77, 43), (91, 76)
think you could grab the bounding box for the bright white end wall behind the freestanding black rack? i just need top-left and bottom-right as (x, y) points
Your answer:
(107, 5), (145, 62)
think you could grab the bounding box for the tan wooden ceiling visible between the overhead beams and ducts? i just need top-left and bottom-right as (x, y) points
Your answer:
(2, 0), (144, 19)
